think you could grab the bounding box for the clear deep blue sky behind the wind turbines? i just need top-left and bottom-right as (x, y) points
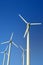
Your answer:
(0, 0), (43, 65)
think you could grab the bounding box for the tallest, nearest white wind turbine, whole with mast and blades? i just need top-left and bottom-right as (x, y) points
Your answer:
(19, 14), (42, 65)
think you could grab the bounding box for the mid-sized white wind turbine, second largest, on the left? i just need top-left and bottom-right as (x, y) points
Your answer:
(1, 33), (18, 65)
